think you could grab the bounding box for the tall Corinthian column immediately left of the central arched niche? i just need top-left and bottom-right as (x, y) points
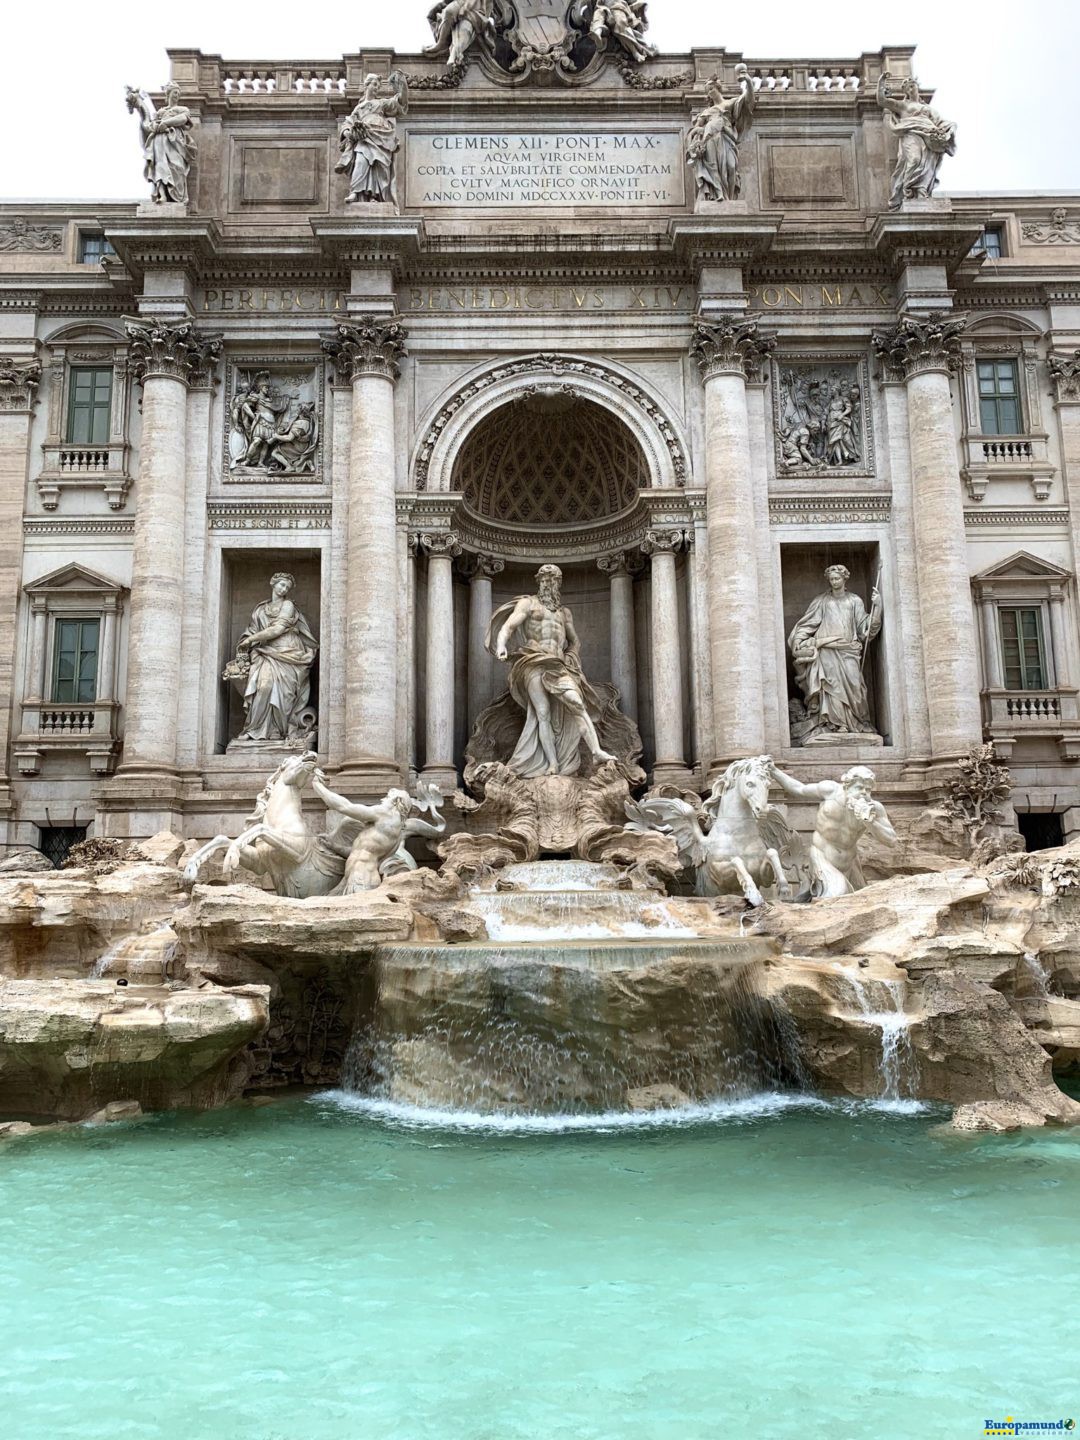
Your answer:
(323, 317), (406, 792)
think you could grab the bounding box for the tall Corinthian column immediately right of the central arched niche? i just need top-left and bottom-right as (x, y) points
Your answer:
(690, 317), (776, 776)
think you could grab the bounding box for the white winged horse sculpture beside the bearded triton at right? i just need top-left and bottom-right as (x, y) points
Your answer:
(626, 755), (796, 906)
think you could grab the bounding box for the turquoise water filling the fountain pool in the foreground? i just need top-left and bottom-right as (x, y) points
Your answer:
(0, 1097), (1080, 1440)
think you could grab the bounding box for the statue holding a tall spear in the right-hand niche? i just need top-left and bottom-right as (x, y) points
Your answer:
(788, 564), (881, 744)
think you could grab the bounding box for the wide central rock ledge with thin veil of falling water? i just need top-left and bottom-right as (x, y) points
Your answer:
(346, 936), (783, 1115)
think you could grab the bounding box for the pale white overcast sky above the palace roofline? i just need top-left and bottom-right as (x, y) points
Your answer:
(0, 0), (1080, 200)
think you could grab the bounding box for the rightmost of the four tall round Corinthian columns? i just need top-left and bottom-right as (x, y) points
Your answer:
(873, 315), (982, 762)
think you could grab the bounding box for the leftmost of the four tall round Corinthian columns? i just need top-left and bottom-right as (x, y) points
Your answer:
(120, 320), (222, 780)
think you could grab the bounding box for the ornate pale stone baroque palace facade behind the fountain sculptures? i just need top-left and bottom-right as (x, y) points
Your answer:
(0, 8), (1080, 851)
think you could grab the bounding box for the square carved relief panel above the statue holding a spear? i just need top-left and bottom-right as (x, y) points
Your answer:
(772, 356), (874, 480)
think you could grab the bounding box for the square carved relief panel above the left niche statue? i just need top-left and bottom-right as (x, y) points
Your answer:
(222, 356), (324, 485)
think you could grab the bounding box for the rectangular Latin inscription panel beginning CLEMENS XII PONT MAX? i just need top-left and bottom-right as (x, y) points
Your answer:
(405, 130), (685, 210)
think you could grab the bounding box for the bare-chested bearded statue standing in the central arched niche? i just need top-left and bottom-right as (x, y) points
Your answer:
(487, 564), (616, 780)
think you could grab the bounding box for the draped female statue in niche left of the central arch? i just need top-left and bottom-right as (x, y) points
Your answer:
(223, 575), (318, 746)
